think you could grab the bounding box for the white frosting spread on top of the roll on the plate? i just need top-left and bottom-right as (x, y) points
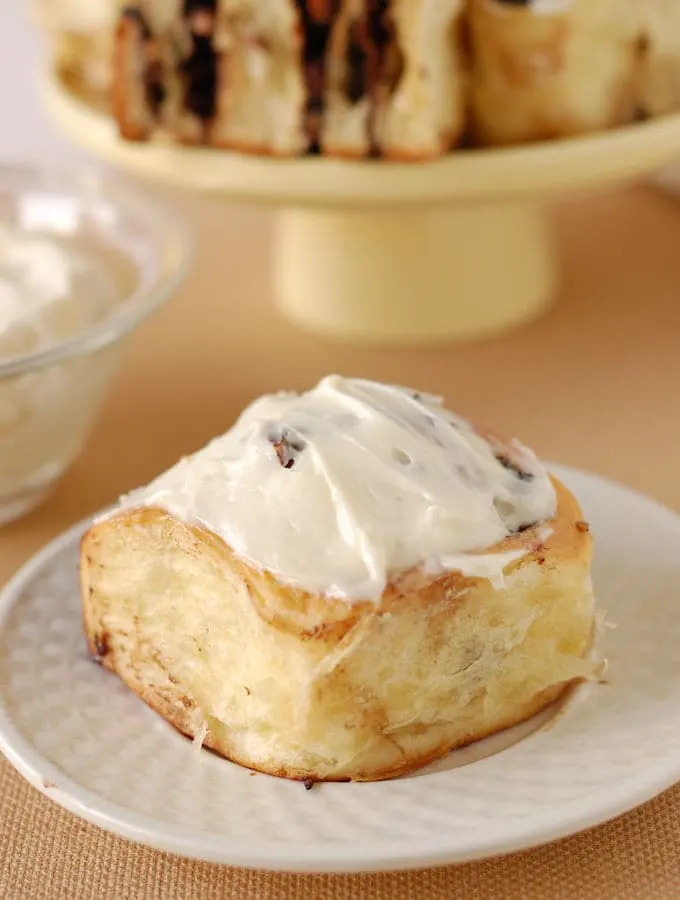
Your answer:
(121, 376), (556, 600)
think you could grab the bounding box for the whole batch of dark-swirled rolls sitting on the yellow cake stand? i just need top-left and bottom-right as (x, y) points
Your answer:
(36, 0), (680, 162)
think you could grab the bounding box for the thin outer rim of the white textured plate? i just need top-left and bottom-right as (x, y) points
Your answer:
(0, 465), (680, 872)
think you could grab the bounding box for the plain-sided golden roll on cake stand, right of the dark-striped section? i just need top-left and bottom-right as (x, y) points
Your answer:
(470, 0), (644, 144)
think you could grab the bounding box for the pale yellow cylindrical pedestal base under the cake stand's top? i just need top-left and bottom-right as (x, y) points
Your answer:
(273, 200), (557, 342)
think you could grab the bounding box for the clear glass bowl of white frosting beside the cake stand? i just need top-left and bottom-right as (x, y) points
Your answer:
(0, 165), (192, 524)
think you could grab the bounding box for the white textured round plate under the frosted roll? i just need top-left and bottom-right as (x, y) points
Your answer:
(0, 469), (680, 871)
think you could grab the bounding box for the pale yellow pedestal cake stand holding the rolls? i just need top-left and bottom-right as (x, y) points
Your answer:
(42, 68), (680, 342)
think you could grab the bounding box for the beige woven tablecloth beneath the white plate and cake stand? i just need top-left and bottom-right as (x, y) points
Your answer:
(0, 188), (680, 900)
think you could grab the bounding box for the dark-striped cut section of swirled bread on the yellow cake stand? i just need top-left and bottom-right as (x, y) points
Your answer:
(114, 0), (464, 159)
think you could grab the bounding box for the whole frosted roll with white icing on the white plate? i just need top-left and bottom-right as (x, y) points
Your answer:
(81, 376), (599, 780)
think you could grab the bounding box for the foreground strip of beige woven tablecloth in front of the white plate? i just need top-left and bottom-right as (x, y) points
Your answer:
(0, 758), (680, 900)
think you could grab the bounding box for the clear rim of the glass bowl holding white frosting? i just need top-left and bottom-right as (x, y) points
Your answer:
(0, 162), (195, 380)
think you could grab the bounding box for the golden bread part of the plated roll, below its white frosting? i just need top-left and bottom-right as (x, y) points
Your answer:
(80, 481), (598, 781)
